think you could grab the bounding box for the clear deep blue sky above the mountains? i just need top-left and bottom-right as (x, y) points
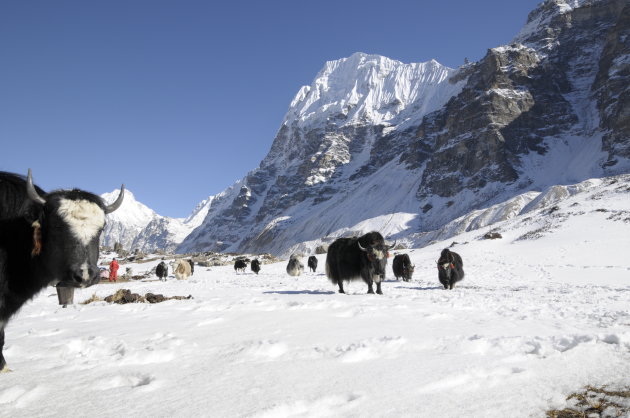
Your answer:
(0, 0), (539, 217)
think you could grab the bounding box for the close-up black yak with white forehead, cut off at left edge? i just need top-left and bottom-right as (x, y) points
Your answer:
(0, 170), (125, 371)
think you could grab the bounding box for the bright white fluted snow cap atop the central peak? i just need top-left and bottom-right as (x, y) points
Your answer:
(284, 53), (462, 124)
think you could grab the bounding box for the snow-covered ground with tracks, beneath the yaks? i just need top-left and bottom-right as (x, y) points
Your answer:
(0, 177), (630, 418)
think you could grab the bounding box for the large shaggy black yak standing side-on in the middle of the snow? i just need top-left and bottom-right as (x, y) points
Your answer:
(326, 232), (396, 295)
